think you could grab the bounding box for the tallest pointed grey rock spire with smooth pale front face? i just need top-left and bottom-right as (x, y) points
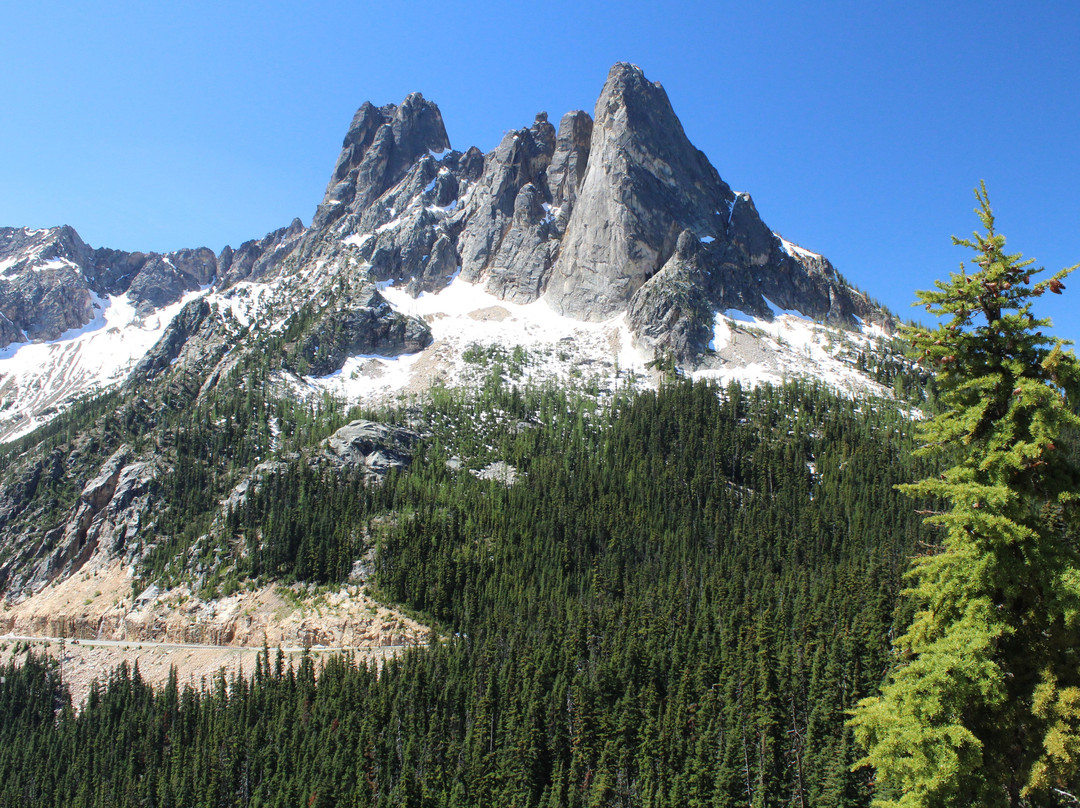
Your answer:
(545, 63), (734, 321)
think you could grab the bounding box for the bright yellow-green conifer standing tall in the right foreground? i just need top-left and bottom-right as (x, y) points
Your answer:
(851, 186), (1080, 808)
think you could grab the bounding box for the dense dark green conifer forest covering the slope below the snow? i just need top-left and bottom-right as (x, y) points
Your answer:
(0, 374), (934, 808)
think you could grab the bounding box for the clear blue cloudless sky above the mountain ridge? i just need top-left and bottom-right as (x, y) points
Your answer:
(0, 0), (1080, 339)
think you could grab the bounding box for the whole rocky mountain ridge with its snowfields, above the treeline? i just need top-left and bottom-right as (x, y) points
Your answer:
(0, 63), (891, 445)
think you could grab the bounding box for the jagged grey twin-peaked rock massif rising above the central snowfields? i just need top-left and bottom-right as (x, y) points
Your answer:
(298, 63), (891, 365)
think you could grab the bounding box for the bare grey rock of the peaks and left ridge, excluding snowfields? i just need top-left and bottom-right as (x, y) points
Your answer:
(0, 63), (888, 397)
